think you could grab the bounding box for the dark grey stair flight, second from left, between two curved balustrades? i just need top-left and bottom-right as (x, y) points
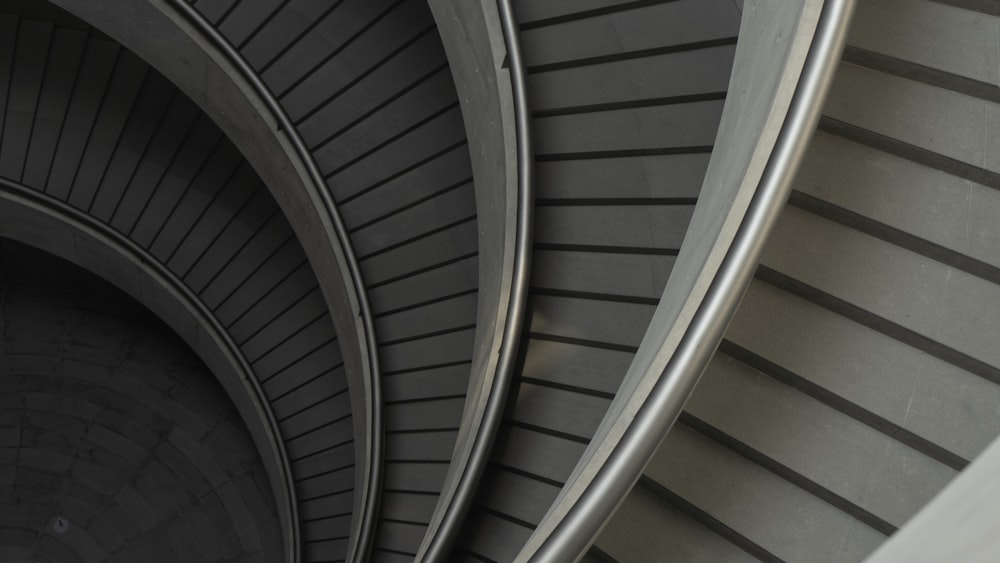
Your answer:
(185, 0), (478, 558)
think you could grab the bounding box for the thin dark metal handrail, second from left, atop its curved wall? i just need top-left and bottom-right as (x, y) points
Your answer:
(167, 0), (384, 561)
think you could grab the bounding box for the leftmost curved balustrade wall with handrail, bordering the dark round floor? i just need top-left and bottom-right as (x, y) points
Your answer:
(0, 178), (301, 561)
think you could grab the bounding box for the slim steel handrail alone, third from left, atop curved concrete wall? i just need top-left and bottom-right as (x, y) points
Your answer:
(423, 0), (535, 562)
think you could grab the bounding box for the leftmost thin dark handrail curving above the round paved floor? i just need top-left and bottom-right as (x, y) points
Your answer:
(0, 181), (300, 561)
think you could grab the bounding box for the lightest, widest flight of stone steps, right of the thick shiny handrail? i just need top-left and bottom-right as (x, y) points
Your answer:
(597, 1), (1000, 561)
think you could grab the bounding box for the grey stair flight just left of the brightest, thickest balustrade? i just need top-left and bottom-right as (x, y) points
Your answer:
(456, 1), (739, 561)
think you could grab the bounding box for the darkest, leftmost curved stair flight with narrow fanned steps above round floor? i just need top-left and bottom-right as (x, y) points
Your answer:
(0, 8), (353, 559)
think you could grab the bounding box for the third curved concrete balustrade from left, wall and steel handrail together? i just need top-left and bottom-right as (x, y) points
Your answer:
(416, 0), (534, 561)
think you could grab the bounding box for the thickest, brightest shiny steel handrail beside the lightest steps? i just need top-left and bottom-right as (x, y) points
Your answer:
(517, 0), (855, 562)
